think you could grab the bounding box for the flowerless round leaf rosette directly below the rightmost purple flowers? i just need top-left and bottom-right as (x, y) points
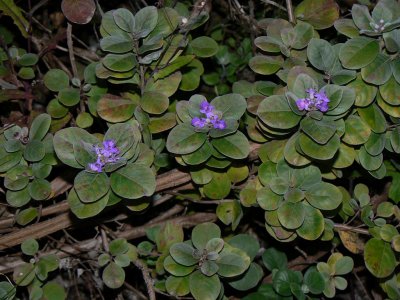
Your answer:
(256, 159), (342, 242)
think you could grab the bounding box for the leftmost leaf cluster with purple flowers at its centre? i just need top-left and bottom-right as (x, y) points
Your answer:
(54, 121), (156, 218)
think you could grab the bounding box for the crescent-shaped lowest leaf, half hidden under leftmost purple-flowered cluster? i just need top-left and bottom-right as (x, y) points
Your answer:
(67, 189), (110, 219)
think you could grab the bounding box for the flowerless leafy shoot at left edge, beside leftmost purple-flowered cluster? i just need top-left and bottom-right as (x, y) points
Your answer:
(0, 114), (57, 225)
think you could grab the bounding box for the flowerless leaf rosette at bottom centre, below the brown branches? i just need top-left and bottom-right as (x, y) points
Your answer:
(164, 223), (250, 299)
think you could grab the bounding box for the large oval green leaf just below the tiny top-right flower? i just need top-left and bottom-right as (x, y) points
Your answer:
(339, 37), (379, 69)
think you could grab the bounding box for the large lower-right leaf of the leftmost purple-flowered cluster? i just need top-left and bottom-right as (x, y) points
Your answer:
(111, 163), (156, 199)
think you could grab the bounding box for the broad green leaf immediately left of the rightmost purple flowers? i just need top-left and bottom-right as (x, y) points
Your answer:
(257, 95), (301, 130)
